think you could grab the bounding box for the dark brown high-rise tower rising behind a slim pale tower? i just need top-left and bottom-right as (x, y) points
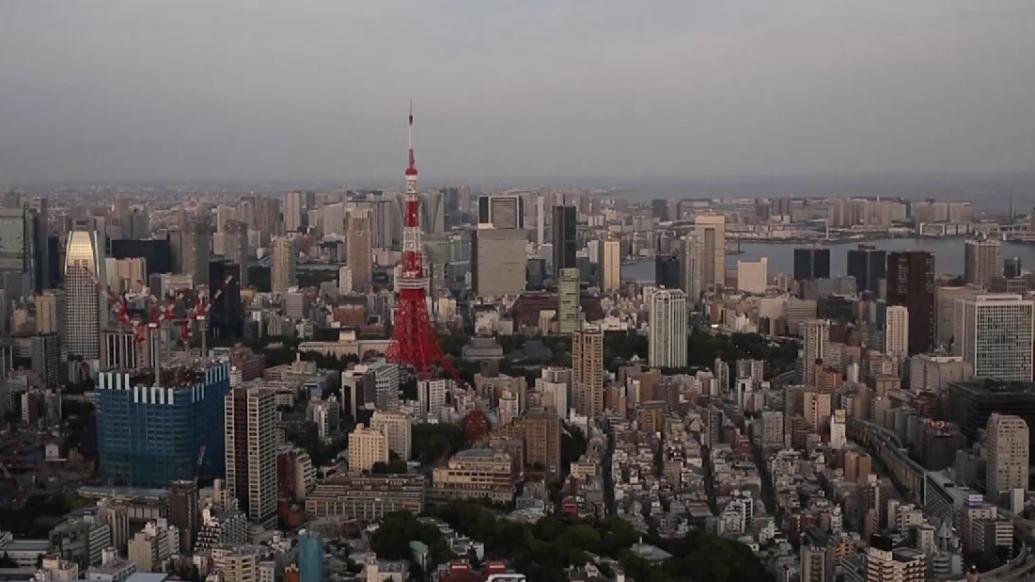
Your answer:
(888, 251), (935, 353)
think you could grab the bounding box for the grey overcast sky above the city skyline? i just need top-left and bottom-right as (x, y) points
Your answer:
(0, 0), (1035, 182)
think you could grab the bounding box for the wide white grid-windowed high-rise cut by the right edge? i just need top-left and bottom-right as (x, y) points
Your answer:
(953, 293), (1035, 382)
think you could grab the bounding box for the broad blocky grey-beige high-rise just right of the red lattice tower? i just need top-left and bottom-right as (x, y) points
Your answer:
(471, 229), (528, 296)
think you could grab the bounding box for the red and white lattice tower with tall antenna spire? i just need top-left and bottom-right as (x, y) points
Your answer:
(387, 103), (456, 378)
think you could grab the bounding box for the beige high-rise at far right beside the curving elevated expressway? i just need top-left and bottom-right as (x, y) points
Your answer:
(984, 412), (1030, 501)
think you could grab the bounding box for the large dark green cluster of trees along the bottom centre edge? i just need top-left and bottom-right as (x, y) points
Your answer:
(424, 501), (770, 582)
